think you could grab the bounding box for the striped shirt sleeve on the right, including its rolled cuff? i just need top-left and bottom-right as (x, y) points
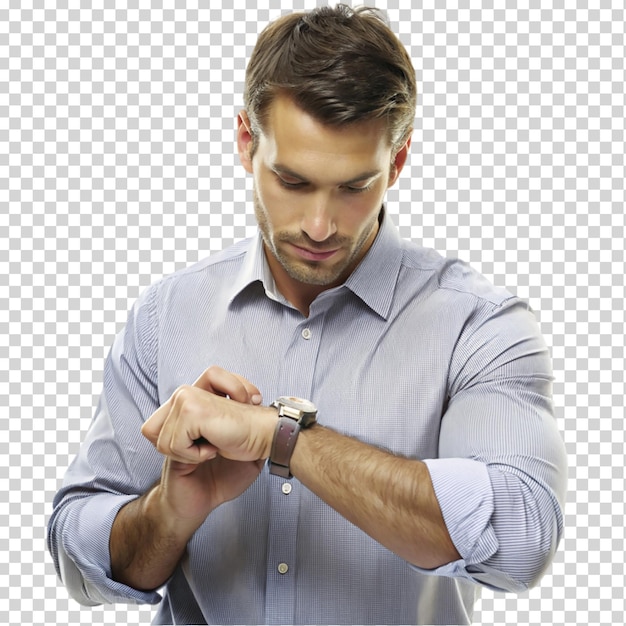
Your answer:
(416, 298), (566, 592)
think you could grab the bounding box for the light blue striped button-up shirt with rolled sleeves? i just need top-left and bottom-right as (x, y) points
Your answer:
(48, 216), (566, 624)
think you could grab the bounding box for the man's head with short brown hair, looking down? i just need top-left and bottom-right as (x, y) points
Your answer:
(237, 5), (415, 307)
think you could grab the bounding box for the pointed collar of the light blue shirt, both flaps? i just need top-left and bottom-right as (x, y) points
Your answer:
(229, 210), (403, 319)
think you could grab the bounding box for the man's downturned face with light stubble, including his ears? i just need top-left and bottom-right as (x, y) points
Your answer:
(238, 97), (408, 295)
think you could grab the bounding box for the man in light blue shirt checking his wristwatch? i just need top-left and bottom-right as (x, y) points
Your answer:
(49, 5), (565, 624)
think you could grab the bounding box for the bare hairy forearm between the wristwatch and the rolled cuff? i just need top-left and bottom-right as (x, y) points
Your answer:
(291, 426), (460, 569)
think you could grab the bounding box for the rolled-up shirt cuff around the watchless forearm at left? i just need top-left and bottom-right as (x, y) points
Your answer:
(59, 494), (161, 605)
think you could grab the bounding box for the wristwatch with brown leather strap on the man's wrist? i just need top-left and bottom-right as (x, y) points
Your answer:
(269, 396), (317, 478)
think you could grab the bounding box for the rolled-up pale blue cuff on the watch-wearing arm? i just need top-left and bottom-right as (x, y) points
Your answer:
(424, 459), (498, 569)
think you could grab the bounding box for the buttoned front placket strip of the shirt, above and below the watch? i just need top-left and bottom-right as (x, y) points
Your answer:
(265, 315), (323, 624)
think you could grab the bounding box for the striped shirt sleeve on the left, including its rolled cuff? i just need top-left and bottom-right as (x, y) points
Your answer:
(48, 288), (163, 606)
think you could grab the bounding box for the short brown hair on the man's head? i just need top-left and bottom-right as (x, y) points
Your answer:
(244, 4), (416, 149)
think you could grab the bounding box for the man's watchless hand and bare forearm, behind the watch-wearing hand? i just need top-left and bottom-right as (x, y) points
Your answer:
(109, 367), (264, 590)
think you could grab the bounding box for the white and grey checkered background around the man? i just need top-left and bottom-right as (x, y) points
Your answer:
(0, 0), (626, 625)
